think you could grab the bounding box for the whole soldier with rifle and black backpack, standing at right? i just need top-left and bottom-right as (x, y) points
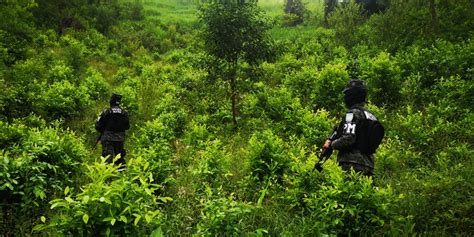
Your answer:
(323, 80), (384, 176)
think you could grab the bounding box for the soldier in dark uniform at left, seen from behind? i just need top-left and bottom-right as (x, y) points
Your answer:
(95, 94), (130, 168)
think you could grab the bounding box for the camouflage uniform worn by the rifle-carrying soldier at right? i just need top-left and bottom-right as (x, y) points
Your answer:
(331, 104), (374, 176)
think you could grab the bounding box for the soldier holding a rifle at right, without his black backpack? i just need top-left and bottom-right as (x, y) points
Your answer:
(323, 80), (376, 176)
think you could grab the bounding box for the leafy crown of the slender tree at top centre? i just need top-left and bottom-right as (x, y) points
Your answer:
(200, 0), (270, 63)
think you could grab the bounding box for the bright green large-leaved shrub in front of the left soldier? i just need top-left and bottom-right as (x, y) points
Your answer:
(35, 157), (169, 236)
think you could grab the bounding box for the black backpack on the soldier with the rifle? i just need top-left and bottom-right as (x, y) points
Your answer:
(356, 110), (385, 155)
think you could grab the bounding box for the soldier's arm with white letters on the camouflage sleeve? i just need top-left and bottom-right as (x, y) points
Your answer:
(331, 112), (357, 150)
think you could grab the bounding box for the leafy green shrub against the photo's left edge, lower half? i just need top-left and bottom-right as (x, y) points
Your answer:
(0, 118), (87, 231)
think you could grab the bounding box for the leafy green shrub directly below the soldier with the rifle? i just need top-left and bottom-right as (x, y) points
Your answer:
(305, 171), (411, 235)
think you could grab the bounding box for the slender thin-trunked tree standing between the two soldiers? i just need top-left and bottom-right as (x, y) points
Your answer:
(199, 0), (272, 125)
